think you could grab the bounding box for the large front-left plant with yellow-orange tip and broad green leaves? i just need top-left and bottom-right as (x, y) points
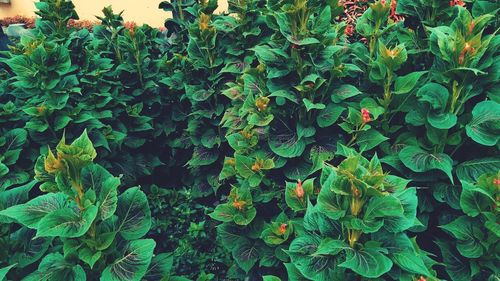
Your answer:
(0, 132), (182, 280)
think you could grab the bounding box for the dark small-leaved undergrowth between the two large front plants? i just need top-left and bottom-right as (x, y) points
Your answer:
(145, 185), (229, 281)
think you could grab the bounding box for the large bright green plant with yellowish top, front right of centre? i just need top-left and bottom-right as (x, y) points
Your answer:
(287, 153), (436, 280)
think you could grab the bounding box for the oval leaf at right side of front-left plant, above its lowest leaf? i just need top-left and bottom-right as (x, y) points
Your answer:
(115, 187), (151, 240)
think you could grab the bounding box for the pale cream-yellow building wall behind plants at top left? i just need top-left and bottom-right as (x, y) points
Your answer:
(0, 0), (227, 27)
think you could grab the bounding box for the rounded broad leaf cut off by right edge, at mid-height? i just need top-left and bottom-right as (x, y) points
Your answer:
(465, 101), (500, 146)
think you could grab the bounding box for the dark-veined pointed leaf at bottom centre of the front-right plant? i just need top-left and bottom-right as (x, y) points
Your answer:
(339, 248), (392, 278)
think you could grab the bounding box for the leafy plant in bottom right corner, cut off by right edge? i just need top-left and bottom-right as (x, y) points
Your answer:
(436, 174), (500, 280)
